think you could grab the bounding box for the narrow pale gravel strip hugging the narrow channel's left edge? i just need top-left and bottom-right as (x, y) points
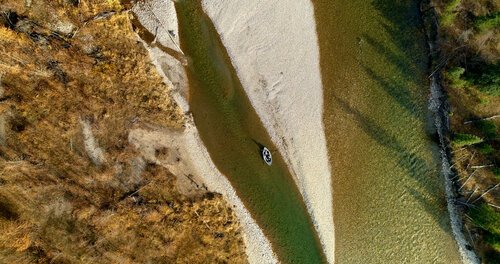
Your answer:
(131, 0), (277, 263)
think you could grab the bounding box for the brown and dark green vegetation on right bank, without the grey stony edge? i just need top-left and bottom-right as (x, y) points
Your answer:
(431, 0), (500, 263)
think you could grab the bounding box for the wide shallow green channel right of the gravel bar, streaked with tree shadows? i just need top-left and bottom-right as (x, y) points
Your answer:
(313, 0), (460, 264)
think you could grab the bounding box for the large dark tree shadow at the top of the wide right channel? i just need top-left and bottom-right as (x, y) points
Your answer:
(361, 0), (429, 118)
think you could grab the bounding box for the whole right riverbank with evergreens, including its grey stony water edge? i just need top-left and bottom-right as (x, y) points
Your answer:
(422, 0), (500, 263)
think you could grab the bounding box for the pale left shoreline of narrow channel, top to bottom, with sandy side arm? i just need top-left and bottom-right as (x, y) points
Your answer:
(130, 0), (278, 263)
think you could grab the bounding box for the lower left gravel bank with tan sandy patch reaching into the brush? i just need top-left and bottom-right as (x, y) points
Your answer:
(129, 124), (277, 263)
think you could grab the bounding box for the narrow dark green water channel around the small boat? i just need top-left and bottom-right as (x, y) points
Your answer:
(175, 0), (325, 263)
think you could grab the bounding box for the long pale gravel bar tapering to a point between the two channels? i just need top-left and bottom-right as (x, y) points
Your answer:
(202, 0), (334, 263)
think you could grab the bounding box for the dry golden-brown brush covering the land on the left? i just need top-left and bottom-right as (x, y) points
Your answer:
(0, 0), (246, 263)
